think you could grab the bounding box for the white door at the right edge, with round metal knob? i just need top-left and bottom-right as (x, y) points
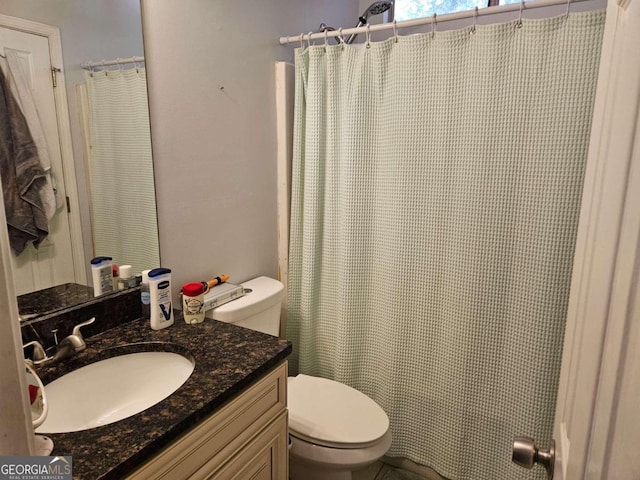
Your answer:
(554, 0), (640, 480)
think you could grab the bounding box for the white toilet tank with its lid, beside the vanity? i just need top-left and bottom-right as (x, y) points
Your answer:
(211, 277), (284, 337)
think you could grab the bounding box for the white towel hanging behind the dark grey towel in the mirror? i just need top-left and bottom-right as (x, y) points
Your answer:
(0, 50), (59, 220)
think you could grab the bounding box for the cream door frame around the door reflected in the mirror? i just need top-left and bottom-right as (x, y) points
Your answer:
(0, 14), (87, 285)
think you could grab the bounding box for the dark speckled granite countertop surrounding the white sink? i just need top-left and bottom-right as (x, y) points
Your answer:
(38, 314), (291, 480)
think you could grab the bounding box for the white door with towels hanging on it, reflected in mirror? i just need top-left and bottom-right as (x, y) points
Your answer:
(0, 28), (76, 295)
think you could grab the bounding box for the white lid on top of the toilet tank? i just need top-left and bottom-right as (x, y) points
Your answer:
(211, 277), (284, 323)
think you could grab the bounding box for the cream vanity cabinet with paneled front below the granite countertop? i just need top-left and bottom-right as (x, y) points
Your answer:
(127, 361), (289, 480)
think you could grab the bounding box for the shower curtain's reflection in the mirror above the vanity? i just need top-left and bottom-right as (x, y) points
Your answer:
(80, 68), (160, 274)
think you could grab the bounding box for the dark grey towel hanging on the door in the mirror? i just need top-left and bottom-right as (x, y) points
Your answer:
(0, 70), (49, 255)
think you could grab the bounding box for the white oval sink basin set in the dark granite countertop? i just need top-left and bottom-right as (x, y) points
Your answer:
(36, 352), (194, 433)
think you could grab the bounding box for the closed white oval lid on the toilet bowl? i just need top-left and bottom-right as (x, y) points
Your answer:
(287, 375), (389, 448)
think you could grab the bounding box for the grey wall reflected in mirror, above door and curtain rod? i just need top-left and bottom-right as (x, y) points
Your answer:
(0, 0), (143, 278)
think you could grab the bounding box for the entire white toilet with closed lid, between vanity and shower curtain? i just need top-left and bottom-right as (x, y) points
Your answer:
(211, 277), (391, 480)
